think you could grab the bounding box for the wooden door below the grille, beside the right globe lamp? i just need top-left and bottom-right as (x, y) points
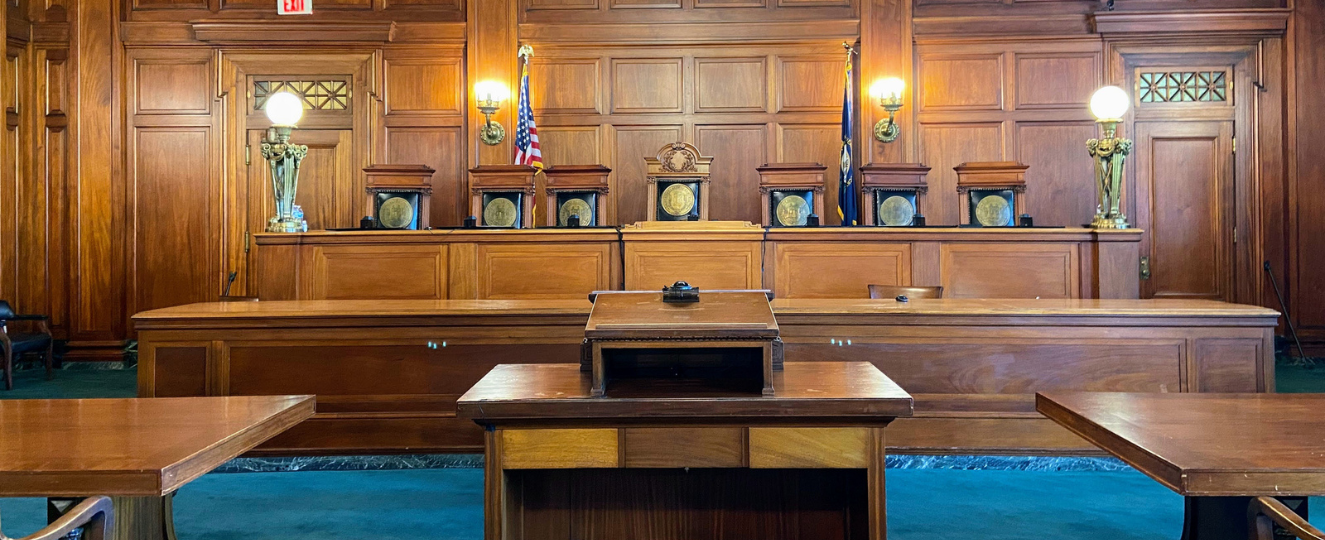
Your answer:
(1133, 120), (1235, 300)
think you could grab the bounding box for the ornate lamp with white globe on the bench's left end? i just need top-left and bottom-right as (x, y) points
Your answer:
(262, 91), (309, 233)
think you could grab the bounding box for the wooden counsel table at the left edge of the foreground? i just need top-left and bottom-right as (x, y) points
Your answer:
(0, 396), (314, 540)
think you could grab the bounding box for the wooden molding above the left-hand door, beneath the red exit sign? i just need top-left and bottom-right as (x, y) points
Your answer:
(191, 21), (396, 44)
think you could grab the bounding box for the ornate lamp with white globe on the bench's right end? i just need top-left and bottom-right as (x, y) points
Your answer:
(1085, 86), (1132, 229)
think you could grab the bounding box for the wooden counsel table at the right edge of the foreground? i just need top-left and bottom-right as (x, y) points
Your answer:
(1036, 392), (1325, 540)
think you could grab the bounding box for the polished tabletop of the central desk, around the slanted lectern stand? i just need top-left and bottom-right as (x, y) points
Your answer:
(457, 361), (912, 422)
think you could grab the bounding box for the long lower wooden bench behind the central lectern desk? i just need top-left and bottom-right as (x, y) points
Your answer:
(134, 297), (1277, 454)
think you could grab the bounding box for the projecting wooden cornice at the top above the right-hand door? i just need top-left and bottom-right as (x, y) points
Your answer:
(1093, 9), (1293, 36)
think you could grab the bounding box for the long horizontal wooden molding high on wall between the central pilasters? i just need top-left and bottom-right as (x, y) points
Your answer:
(519, 19), (860, 45)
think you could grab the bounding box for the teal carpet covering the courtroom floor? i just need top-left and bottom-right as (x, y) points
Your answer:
(0, 357), (1325, 540)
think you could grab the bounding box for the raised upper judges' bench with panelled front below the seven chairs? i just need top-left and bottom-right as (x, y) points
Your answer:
(249, 221), (1141, 300)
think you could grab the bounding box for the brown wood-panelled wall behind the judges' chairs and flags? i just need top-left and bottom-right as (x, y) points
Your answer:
(0, 0), (1303, 359)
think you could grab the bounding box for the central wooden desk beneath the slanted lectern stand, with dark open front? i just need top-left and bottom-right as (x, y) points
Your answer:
(457, 363), (912, 540)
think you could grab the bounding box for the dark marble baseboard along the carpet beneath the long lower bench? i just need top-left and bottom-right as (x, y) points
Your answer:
(216, 454), (1132, 473)
